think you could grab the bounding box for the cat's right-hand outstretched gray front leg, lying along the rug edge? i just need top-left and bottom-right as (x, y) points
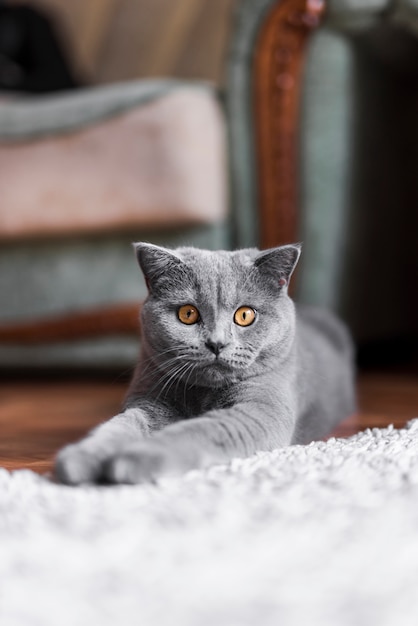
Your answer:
(106, 403), (295, 484)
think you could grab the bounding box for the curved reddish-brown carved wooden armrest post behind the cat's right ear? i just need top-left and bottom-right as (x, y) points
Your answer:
(253, 0), (325, 248)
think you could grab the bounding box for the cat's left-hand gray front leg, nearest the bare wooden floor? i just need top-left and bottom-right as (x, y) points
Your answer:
(54, 406), (168, 485)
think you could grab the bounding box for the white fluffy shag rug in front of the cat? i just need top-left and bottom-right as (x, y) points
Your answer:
(0, 420), (418, 626)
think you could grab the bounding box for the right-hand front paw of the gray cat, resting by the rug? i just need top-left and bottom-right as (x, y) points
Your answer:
(104, 441), (187, 485)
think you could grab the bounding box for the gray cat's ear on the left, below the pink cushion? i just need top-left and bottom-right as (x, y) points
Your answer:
(133, 242), (184, 291)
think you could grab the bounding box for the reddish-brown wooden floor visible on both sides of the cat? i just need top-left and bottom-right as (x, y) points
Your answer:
(0, 373), (418, 473)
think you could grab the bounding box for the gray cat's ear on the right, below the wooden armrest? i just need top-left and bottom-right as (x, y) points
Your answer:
(254, 243), (302, 288)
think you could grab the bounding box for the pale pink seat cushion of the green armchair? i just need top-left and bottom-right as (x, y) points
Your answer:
(0, 88), (227, 239)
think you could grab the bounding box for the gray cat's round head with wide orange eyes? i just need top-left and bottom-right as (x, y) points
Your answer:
(135, 243), (300, 387)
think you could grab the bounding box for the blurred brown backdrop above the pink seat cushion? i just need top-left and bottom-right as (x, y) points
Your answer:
(1, 0), (235, 85)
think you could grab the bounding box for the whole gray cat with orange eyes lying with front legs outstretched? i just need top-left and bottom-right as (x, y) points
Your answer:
(55, 243), (355, 485)
